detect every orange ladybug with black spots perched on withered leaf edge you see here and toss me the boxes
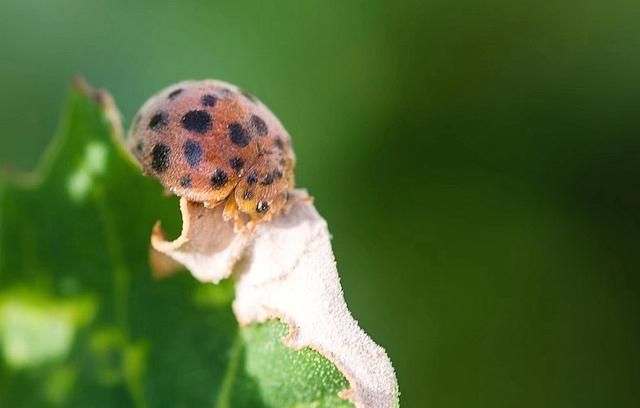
[127,80,295,224]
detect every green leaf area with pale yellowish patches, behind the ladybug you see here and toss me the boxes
[0,79,352,407]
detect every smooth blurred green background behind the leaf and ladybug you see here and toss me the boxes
[0,0,640,407]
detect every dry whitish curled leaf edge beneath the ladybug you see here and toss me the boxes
[151,196,398,408]
